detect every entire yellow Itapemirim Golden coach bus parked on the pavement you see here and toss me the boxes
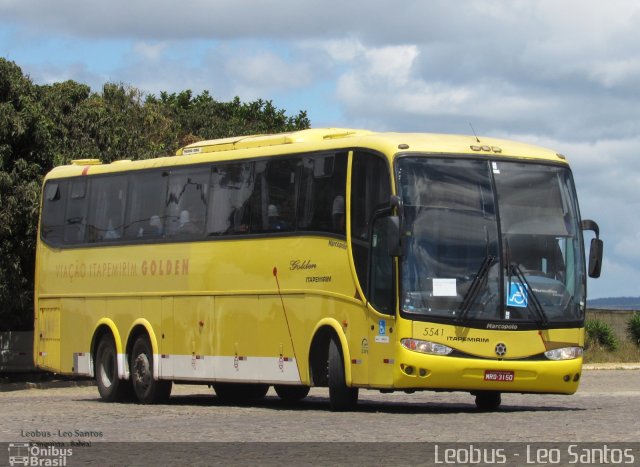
[34,128,602,410]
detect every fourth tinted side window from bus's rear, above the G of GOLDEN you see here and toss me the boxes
[124,170,168,239]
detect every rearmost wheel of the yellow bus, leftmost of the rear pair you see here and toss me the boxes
[95,336,133,402]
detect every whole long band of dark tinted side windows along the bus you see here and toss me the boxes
[42,152,347,249]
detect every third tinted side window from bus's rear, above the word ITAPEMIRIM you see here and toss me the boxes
[87,175,127,243]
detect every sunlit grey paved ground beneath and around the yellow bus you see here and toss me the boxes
[0,370,640,466]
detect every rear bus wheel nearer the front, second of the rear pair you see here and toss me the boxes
[131,336,171,404]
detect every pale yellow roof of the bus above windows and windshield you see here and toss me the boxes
[47,128,566,178]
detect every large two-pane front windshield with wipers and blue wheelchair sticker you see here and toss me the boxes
[397,156,585,326]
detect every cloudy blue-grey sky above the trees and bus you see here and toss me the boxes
[0,0,640,298]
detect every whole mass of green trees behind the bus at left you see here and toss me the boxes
[0,58,310,331]
